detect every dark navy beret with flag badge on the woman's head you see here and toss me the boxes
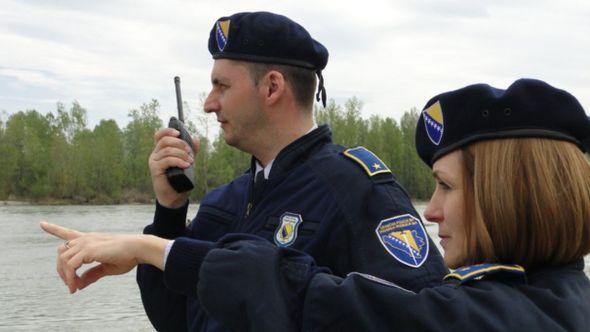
[416,79,590,167]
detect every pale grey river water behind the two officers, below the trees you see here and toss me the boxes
[0,205,590,331]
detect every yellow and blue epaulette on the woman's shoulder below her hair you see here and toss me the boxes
[444,264,525,284]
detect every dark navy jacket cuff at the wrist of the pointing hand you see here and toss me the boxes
[164,237,218,298]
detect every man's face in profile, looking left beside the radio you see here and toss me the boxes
[205,59,264,152]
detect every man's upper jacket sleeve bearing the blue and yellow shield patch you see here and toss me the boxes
[328,174,448,292]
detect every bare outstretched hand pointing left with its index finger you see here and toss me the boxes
[40,222,168,293]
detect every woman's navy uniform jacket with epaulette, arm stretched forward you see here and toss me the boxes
[198,236,590,331]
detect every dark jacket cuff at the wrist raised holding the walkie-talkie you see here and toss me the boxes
[143,200,188,239]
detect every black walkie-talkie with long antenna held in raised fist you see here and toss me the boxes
[166,76,195,193]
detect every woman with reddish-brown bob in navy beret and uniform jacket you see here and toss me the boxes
[198,79,590,331]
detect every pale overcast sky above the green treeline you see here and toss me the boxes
[0,0,590,132]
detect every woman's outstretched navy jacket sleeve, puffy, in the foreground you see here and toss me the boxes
[198,239,542,331]
